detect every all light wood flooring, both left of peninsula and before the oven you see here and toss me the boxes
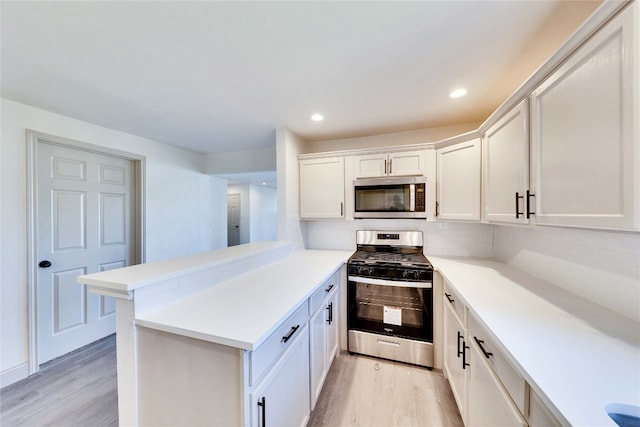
[0,336,462,427]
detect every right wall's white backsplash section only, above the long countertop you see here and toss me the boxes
[493,225,640,321]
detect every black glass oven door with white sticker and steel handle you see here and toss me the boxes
[347,276,433,342]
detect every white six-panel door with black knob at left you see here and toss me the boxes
[36,141,135,364]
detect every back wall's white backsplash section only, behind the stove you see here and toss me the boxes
[306,219,493,258]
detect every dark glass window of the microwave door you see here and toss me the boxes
[355,185,411,212]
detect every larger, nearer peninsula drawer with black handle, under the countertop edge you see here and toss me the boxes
[249,300,308,385]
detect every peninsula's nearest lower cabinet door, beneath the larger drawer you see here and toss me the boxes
[249,326,311,427]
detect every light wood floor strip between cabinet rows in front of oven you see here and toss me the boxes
[308,352,463,427]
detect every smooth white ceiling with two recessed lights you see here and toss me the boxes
[0,1,597,153]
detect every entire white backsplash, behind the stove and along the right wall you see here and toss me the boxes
[304,219,640,322]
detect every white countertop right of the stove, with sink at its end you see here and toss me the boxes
[429,256,640,426]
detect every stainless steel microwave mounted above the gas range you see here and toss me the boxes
[353,176,427,218]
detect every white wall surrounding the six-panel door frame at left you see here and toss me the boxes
[0,99,226,385]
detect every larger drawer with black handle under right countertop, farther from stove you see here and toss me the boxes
[468,315,526,414]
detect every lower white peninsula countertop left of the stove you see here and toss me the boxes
[136,250,352,350]
